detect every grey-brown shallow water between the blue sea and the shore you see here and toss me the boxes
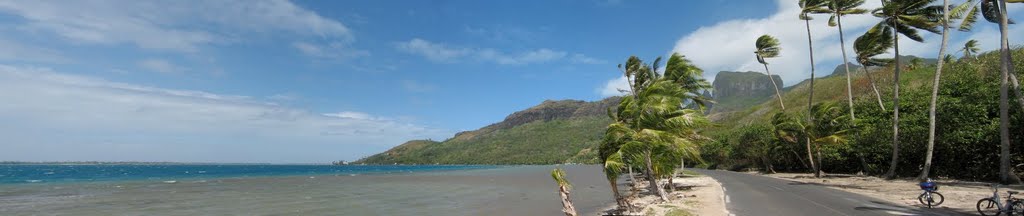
[0,166,614,215]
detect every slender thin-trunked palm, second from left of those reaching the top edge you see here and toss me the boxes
[828,0,867,120]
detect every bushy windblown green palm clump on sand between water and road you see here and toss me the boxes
[602,54,710,201]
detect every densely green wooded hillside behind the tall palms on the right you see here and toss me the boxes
[701,48,1024,180]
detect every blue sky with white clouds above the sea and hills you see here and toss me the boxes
[0,0,1024,163]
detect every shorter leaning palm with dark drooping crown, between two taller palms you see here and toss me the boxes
[853,26,893,112]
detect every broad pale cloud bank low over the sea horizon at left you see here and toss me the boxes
[0,66,451,163]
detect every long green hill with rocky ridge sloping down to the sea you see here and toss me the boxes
[354,97,622,165]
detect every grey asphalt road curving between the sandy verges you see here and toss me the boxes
[694,169,961,216]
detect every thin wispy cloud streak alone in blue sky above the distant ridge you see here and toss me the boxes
[395,38,603,64]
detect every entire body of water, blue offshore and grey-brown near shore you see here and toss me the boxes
[0,165,625,215]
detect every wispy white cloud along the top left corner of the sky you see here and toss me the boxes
[0,0,354,52]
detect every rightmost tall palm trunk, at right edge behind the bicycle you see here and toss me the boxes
[999,0,1020,184]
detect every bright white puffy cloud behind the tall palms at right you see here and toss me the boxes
[659,0,1024,89]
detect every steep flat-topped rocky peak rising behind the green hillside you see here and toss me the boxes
[709,72,783,113]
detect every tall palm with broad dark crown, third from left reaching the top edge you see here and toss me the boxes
[871,0,942,179]
